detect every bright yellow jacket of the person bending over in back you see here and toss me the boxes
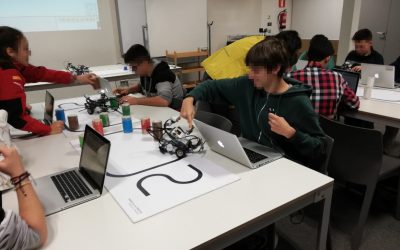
[201,36,265,80]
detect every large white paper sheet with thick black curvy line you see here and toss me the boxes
[105,131,240,222]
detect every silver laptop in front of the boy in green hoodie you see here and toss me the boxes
[194,119,282,168]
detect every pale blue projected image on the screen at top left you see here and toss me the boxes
[0,0,100,32]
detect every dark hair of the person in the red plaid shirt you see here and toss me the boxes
[307,34,335,62]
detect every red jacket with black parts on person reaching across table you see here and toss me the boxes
[0,64,74,135]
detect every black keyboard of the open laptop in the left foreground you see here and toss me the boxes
[51,170,92,202]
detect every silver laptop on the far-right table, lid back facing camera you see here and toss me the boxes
[361,63,395,89]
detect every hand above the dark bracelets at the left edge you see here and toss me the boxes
[0,146,25,178]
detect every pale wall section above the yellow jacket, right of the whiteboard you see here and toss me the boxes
[207,0,261,52]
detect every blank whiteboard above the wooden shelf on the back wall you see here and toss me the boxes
[146,0,207,57]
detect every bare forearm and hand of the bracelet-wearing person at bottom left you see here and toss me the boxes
[0,147,47,245]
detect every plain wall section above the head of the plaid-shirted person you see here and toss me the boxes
[292,0,347,40]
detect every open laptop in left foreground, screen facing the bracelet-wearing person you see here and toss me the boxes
[34,125,111,215]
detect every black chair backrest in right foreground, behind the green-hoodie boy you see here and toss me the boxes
[320,116,383,185]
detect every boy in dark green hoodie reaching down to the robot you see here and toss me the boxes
[181,38,324,168]
